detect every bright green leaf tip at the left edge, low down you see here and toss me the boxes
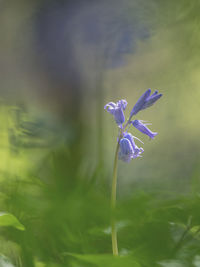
[0,212,25,231]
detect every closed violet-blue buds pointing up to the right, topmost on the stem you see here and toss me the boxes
[129,89,162,117]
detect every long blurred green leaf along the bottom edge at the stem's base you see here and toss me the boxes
[65,253,141,267]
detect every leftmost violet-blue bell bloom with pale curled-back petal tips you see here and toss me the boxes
[104,99,127,126]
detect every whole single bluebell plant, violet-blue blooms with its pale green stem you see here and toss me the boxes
[104,89,162,256]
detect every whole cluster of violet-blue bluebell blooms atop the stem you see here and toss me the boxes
[104,89,162,162]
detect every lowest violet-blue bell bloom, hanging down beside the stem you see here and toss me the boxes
[119,133,144,162]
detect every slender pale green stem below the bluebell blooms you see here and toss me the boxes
[111,142,119,255]
